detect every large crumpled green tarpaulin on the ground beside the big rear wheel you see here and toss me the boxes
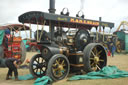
[68,66,128,81]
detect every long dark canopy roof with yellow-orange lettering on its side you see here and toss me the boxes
[19,11,114,29]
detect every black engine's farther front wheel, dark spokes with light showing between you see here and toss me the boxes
[29,54,47,77]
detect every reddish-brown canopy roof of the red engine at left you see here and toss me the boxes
[0,24,30,31]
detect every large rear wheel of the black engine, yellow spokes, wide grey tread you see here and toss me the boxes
[83,43,107,72]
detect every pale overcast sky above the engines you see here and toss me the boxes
[0,0,128,30]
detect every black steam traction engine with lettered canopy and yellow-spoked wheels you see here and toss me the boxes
[19,0,114,81]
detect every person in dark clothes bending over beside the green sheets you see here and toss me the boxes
[5,58,22,80]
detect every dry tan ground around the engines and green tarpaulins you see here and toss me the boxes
[0,53,128,85]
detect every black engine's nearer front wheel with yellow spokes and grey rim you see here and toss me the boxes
[47,54,70,81]
